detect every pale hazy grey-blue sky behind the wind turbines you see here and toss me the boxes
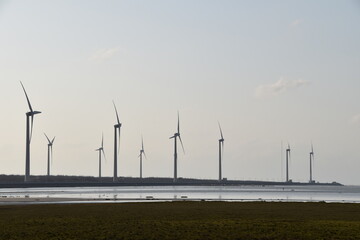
[0,0,360,184]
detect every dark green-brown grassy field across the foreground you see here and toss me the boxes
[0,202,360,240]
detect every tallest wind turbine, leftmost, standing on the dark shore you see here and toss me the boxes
[20,81,41,182]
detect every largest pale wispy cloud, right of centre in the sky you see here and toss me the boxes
[255,78,309,98]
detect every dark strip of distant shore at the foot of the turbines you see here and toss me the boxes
[0,175,342,188]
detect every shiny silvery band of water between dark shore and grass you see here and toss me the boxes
[0,186,360,203]
